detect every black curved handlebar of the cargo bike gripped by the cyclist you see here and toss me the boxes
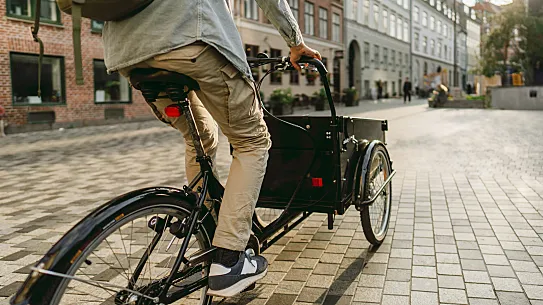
[247,56,337,121]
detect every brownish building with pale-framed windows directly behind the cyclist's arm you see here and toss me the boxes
[233,0,345,99]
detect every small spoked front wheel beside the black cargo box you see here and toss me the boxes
[360,143,392,246]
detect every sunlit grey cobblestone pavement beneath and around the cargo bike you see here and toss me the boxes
[0,100,543,305]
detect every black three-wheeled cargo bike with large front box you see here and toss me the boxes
[11,55,395,305]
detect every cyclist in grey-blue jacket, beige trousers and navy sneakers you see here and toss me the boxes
[103,0,322,297]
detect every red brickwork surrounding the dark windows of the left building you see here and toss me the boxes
[0,0,152,131]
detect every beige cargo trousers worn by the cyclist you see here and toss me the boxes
[119,42,271,251]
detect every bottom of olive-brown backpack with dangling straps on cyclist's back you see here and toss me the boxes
[32,0,153,95]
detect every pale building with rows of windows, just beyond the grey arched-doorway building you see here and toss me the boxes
[411,0,454,88]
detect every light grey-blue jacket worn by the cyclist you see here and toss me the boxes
[102,0,303,79]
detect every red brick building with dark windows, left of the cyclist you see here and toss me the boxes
[0,0,152,133]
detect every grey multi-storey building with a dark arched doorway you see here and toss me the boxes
[345,0,411,97]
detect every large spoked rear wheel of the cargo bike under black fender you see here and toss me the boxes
[50,198,214,305]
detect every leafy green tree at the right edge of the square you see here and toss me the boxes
[478,2,543,83]
